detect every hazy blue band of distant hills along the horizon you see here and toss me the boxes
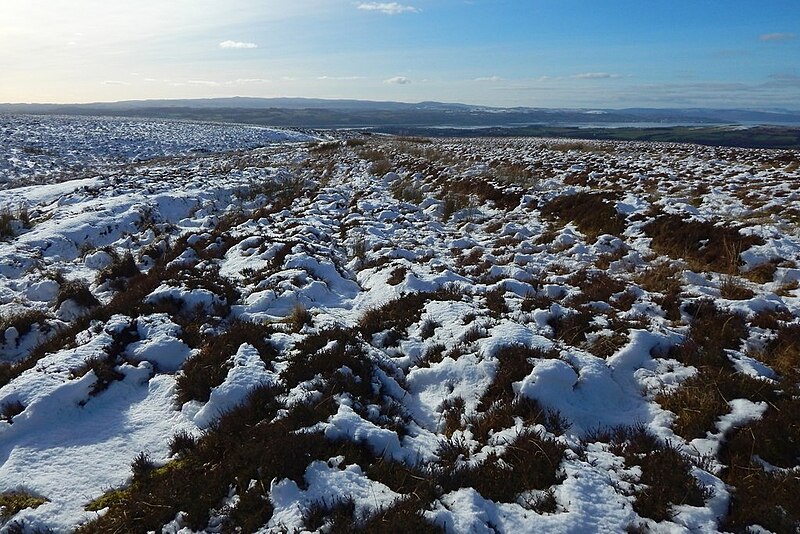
[0,97,800,128]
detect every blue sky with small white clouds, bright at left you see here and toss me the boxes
[0,0,800,110]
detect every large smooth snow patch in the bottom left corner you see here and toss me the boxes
[0,363,193,530]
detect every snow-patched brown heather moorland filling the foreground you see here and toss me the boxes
[0,119,800,532]
